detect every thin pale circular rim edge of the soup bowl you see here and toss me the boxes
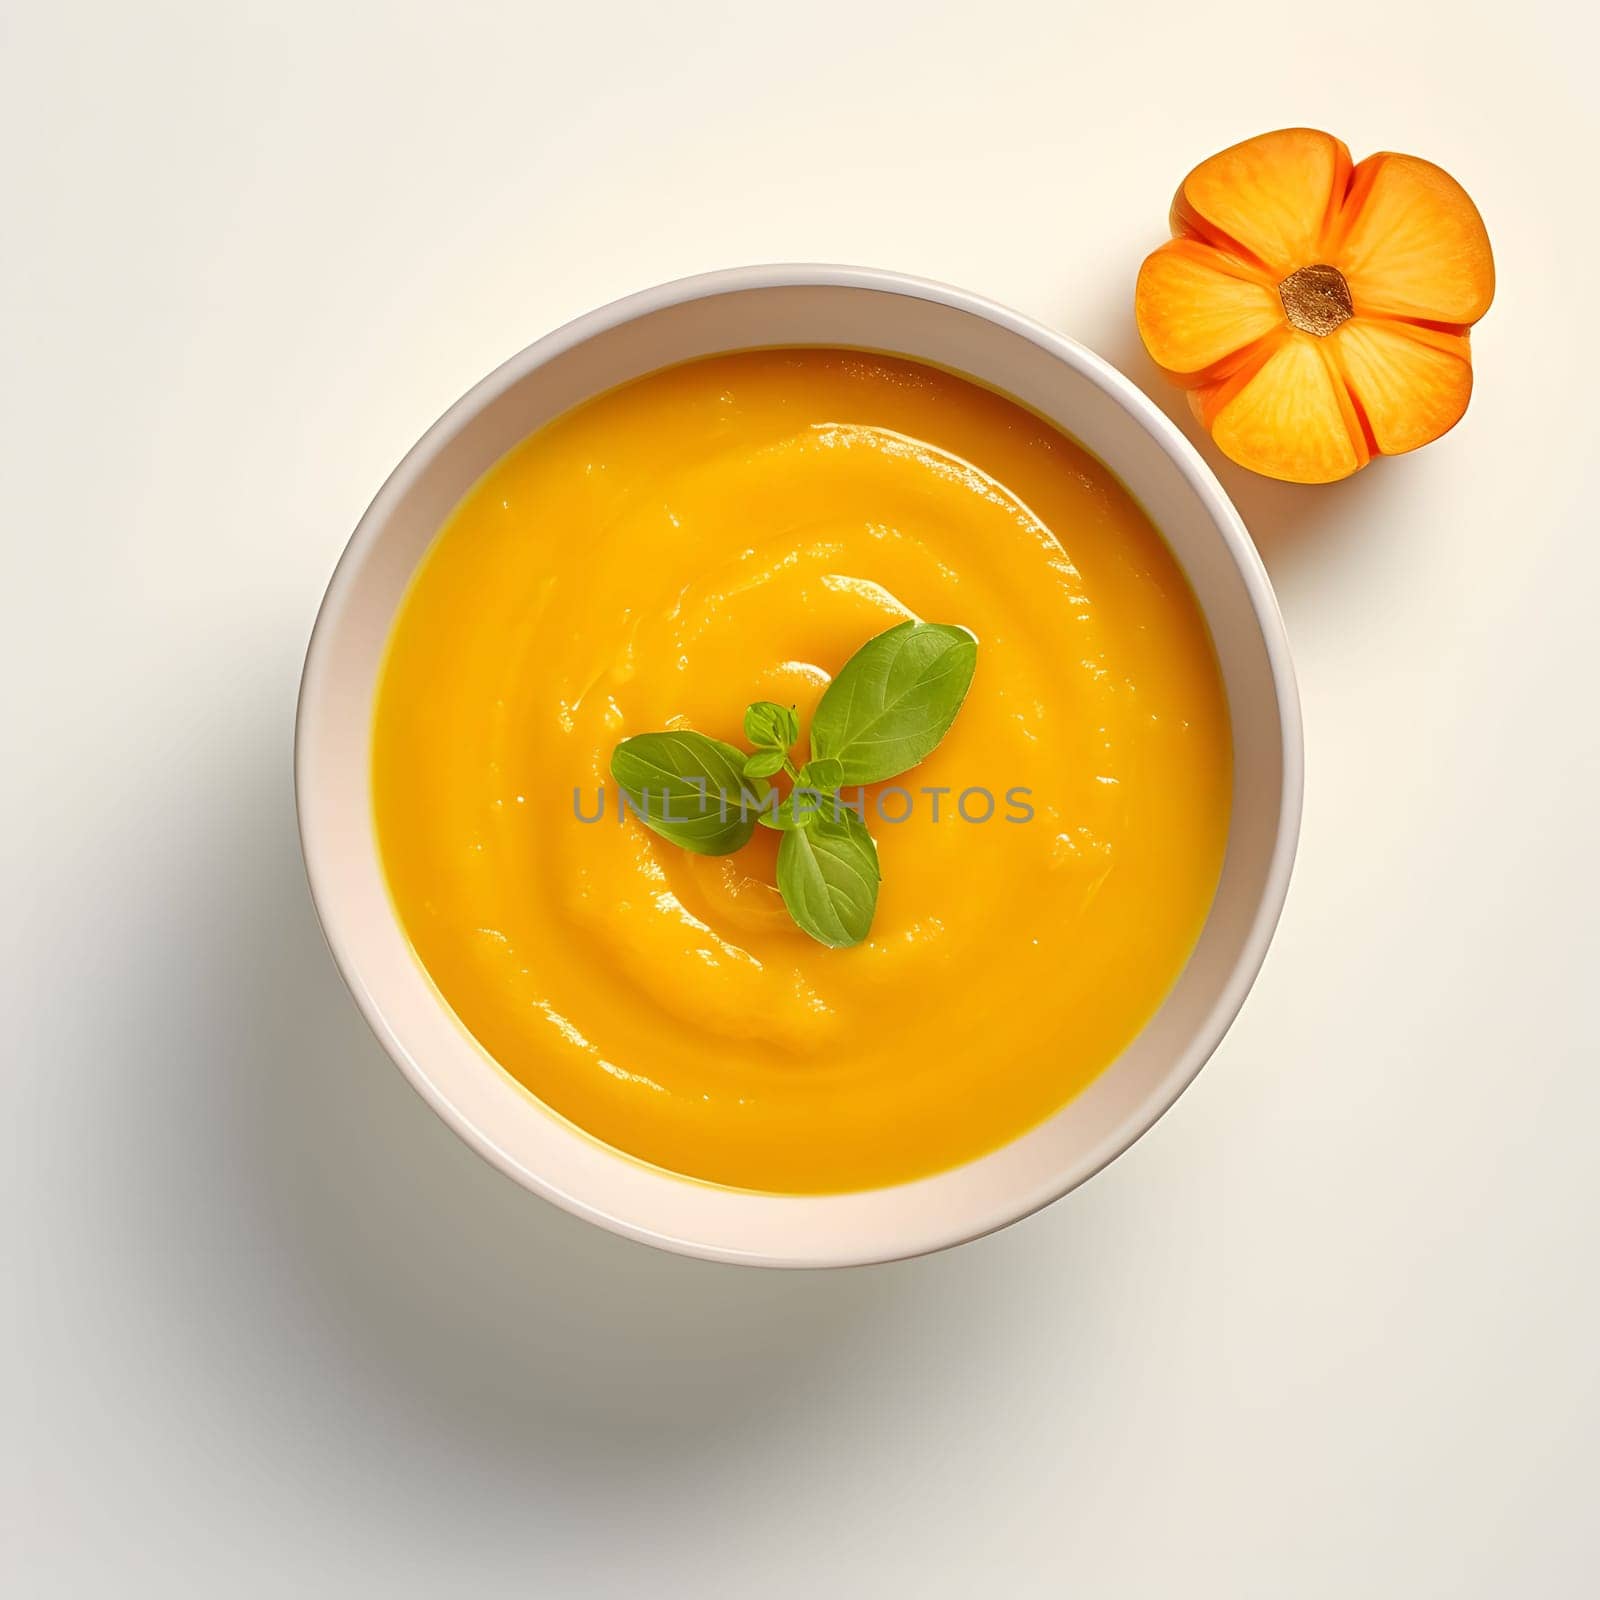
[294,262,1306,1267]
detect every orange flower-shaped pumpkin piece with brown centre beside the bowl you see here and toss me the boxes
[1134,128,1494,483]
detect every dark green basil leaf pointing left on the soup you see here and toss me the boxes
[611,731,771,856]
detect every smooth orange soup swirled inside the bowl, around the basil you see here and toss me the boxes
[373,349,1232,1192]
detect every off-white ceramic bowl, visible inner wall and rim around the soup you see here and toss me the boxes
[294,266,1302,1267]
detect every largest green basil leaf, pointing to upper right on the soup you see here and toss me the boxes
[811,622,978,784]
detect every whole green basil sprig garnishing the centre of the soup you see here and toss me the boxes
[611,622,978,947]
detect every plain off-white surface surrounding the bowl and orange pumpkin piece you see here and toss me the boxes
[0,0,1600,1600]
